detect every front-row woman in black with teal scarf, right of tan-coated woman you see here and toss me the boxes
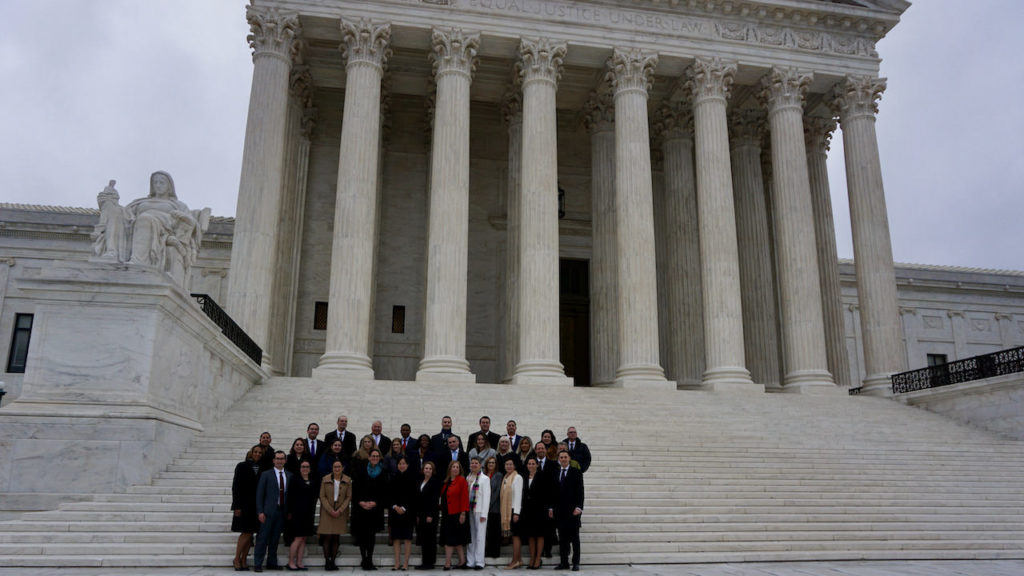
[352,448,387,570]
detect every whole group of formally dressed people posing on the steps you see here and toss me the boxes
[231,415,591,572]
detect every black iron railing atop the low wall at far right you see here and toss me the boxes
[892,346,1024,394]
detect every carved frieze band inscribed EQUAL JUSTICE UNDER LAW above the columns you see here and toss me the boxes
[408,0,878,57]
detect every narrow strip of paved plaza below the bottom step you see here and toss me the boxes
[0,560,1024,576]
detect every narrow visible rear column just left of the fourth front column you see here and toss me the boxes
[502,91,522,382]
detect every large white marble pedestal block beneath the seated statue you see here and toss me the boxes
[0,262,264,493]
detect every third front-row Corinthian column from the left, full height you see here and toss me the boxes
[416,29,480,382]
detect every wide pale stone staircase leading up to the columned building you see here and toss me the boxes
[0,378,1024,567]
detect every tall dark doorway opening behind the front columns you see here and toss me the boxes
[558,258,590,386]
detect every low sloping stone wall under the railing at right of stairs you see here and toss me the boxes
[897,373,1024,440]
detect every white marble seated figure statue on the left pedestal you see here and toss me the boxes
[92,171,210,289]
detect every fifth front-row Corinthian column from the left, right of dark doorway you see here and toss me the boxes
[608,48,676,389]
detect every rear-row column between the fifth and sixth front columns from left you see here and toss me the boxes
[654,99,705,386]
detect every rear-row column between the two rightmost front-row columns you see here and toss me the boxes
[804,117,850,387]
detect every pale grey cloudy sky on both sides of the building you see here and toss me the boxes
[0,0,1024,270]
